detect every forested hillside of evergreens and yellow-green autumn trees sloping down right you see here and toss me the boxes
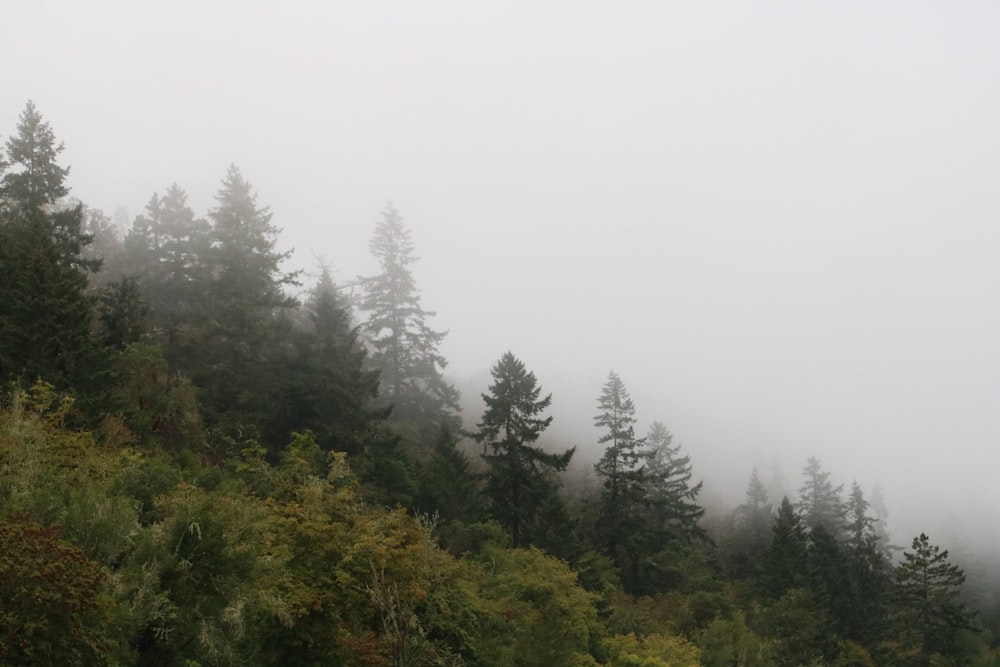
[0,103,1000,667]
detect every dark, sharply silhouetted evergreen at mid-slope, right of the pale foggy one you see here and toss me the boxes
[475,352,574,547]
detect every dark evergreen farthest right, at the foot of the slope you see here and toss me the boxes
[893,533,973,667]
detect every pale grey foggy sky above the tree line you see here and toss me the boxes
[0,0,1000,548]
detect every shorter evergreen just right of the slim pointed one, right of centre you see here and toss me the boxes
[644,422,708,541]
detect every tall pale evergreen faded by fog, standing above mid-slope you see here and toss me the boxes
[361,204,461,441]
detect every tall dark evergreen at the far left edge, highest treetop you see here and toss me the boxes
[0,102,107,397]
